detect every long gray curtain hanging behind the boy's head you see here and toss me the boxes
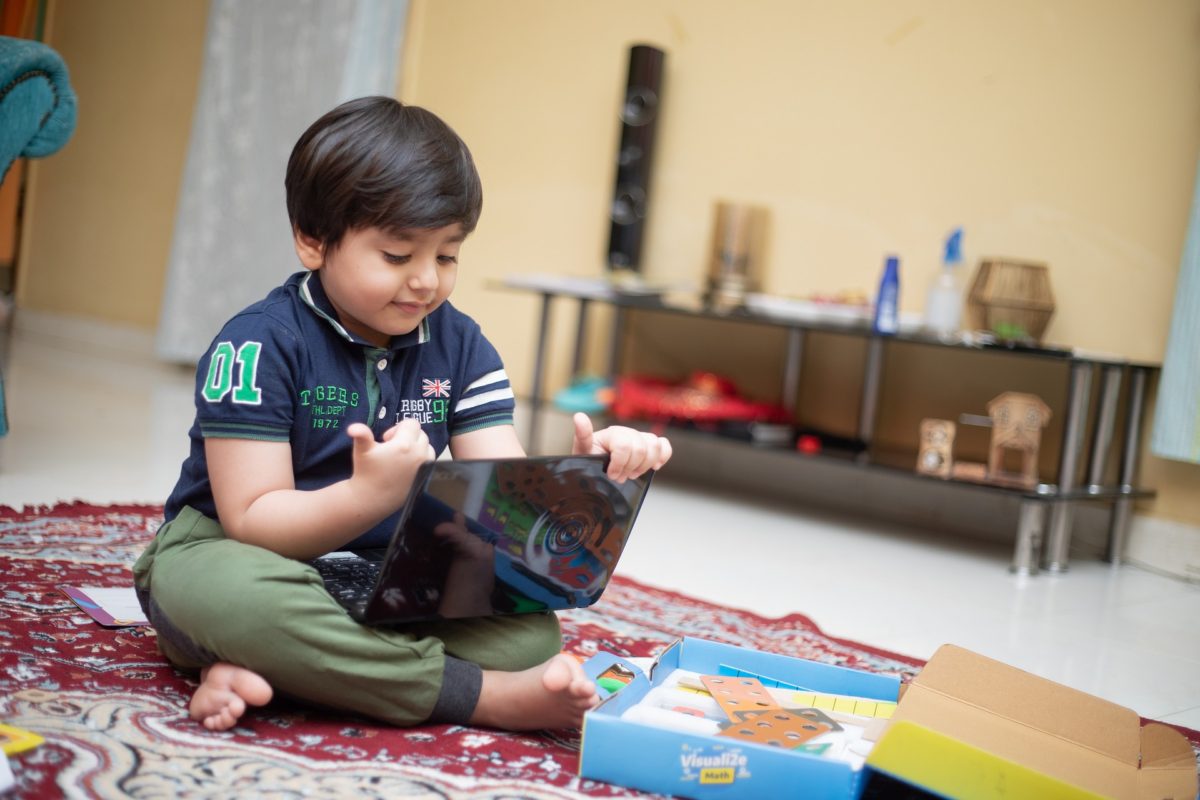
[157,0,408,362]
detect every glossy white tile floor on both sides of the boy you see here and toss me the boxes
[0,319,1200,728]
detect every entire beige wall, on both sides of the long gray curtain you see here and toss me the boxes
[20,0,1200,524]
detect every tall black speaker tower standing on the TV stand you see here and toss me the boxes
[608,44,666,272]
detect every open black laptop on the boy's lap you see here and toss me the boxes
[304,456,654,625]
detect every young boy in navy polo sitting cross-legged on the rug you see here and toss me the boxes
[134,97,671,730]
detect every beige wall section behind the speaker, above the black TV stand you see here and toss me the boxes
[403,0,1200,360]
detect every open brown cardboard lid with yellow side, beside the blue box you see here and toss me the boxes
[868,644,1198,800]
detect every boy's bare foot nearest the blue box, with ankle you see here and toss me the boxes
[470,652,600,730]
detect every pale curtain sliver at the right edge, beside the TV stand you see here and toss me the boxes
[1150,158,1200,463]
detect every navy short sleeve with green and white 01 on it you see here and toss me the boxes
[196,313,300,441]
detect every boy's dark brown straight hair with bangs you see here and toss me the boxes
[283,97,484,248]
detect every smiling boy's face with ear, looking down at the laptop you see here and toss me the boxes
[295,224,466,347]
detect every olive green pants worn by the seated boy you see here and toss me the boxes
[133,507,562,726]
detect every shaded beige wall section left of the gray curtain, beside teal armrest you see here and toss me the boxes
[17,0,208,329]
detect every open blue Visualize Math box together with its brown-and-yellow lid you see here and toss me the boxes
[580,638,1198,800]
